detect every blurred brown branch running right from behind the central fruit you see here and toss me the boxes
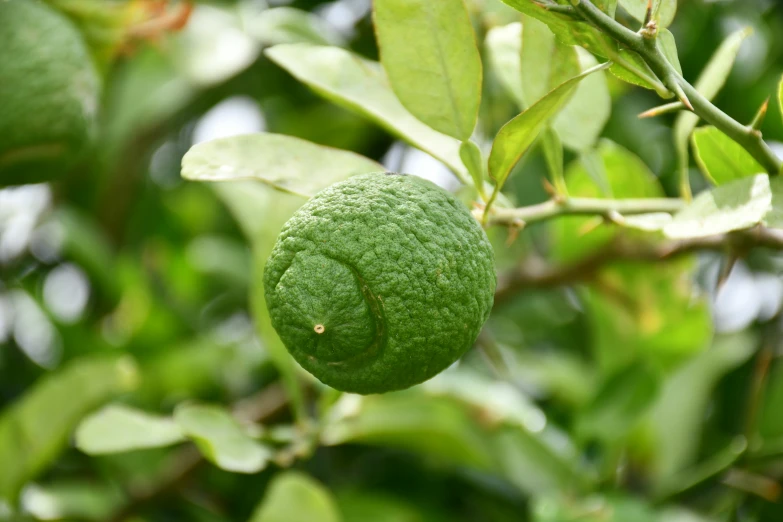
[495,227,783,305]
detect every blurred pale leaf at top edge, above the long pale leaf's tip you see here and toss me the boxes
[244,7,345,46]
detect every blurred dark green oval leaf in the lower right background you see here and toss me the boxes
[576,363,660,443]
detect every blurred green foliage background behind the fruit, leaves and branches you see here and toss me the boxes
[0,0,783,522]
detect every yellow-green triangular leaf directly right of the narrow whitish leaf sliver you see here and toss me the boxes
[520,16,581,107]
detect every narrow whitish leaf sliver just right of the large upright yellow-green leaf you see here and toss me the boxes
[484,22,525,109]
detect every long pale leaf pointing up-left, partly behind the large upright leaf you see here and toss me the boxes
[266,44,469,183]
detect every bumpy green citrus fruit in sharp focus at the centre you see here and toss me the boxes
[264,173,496,394]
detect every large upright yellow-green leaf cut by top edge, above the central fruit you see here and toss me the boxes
[373,0,482,141]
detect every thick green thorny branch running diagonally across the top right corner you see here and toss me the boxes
[571,0,783,176]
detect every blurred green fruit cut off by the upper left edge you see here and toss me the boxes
[0,0,100,186]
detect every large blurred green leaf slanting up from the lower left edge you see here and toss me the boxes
[0,357,138,503]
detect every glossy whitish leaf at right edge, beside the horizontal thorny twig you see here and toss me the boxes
[663,174,772,239]
